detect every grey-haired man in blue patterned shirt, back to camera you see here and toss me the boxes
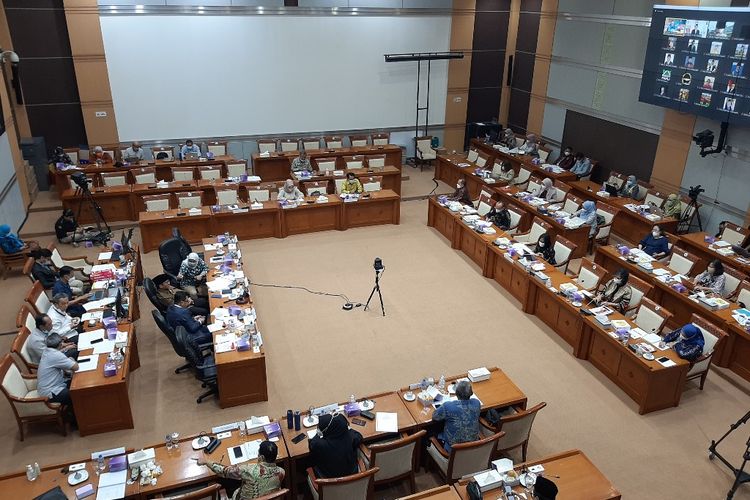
[432,380,481,453]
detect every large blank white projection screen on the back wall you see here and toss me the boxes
[101,15,451,142]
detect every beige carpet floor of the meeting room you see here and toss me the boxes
[0,171,750,499]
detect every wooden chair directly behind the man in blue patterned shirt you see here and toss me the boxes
[427,432,504,484]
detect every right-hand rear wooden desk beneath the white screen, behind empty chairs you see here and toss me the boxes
[252,144,401,181]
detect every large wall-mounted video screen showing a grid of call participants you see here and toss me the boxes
[639,5,750,123]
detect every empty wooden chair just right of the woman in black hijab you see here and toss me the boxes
[359,429,427,493]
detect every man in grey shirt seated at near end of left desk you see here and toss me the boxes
[36,333,78,406]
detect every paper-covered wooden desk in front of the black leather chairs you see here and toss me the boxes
[203,238,268,408]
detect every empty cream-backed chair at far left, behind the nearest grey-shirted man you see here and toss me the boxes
[0,354,67,441]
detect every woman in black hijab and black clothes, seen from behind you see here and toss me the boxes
[307,413,362,478]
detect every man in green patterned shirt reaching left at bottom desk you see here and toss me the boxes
[196,441,285,500]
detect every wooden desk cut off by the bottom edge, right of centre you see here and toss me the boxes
[452,450,621,500]
